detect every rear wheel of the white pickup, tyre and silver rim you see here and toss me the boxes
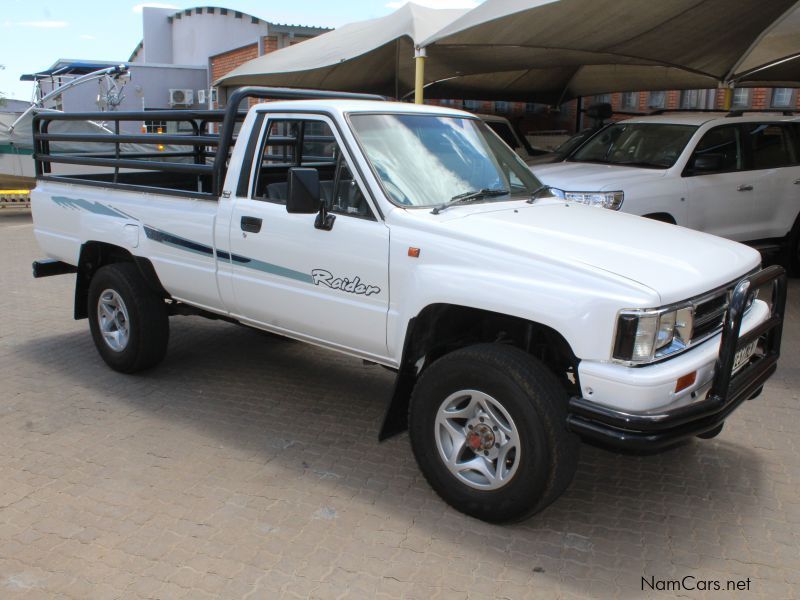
[89,263,169,373]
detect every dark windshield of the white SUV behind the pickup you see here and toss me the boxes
[569,122,697,169]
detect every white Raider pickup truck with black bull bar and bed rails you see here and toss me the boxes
[32,88,786,522]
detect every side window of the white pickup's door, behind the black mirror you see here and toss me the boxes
[253,119,374,218]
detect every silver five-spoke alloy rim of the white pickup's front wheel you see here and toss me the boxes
[435,390,520,490]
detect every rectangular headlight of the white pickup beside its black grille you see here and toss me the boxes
[613,306,694,364]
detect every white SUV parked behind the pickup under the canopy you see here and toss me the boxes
[533,113,800,270]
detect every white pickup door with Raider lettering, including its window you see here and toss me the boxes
[229,115,389,357]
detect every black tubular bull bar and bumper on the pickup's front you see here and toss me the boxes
[567,267,786,451]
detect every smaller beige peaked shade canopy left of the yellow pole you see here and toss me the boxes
[214,3,467,97]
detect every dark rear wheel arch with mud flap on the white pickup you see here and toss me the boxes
[74,241,169,320]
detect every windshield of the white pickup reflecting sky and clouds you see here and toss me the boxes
[350,114,541,207]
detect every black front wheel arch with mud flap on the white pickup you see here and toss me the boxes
[379,303,579,440]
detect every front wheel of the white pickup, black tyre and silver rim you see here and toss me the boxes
[409,344,579,523]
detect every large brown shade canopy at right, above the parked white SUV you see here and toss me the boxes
[422,0,800,101]
